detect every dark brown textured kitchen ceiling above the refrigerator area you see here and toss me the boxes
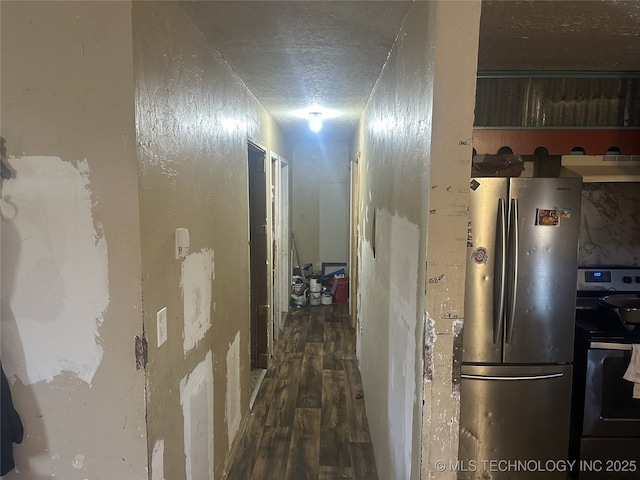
[478,0,640,72]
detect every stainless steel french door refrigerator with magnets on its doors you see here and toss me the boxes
[458,174,582,480]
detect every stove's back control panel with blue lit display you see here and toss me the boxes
[578,267,640,292]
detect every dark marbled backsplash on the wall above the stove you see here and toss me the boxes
[578,183,640,266]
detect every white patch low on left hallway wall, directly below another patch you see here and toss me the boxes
[180,351,213,480]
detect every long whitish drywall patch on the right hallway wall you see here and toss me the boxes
[357,209,422,480]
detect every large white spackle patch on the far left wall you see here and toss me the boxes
[2,157,109,384]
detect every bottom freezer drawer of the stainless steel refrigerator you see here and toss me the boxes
[458,365,572,480]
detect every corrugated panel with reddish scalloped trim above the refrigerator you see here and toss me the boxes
[473,72,640,161]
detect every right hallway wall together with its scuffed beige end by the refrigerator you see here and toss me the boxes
[353,2,480,480]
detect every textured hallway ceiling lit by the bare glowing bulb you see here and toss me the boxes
[183,0,410,139]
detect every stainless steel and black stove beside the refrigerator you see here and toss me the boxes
[571,267,640,480]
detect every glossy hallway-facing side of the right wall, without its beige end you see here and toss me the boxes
[356,2,431,480]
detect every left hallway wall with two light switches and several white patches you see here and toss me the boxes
[133,1,288,479]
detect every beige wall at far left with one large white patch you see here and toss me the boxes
[0,1,148,480]
